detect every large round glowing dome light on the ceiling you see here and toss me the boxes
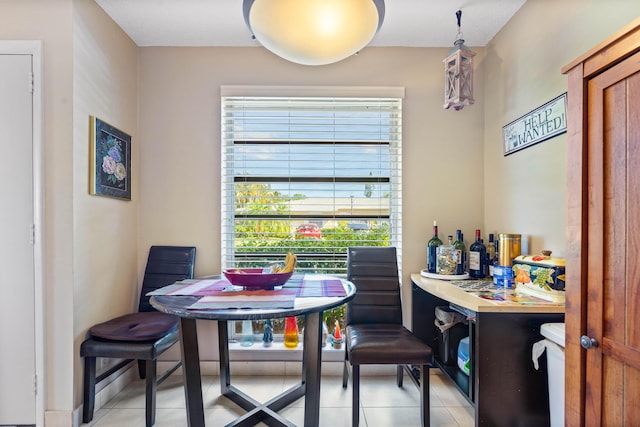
[242,0,385,65]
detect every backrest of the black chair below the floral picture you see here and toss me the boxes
[138,246,196,311]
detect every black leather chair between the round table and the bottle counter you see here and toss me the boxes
[342,247,433,427]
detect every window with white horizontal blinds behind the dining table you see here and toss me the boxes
[222,88,402,348]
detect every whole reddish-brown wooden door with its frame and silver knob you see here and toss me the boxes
[563,20,640,426]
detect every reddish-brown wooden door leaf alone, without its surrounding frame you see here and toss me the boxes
[585,53,640,426]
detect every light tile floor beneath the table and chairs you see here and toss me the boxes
[84,369,474,427]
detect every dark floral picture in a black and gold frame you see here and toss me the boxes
[89,116,131,200]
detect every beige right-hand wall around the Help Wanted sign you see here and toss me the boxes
[484,0,640,257]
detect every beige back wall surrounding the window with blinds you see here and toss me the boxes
[139,48,484,357]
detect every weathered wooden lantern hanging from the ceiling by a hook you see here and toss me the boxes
[442,10,476,111]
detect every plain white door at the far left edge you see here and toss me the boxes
[0,55,36,425]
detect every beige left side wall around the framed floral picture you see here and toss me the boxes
[73,0,138,407]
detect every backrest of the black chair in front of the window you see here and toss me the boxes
[346,247,402,325]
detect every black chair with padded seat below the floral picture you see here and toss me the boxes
[80,246,196,427]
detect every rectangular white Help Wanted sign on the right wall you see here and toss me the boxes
[502,92,567,156]
